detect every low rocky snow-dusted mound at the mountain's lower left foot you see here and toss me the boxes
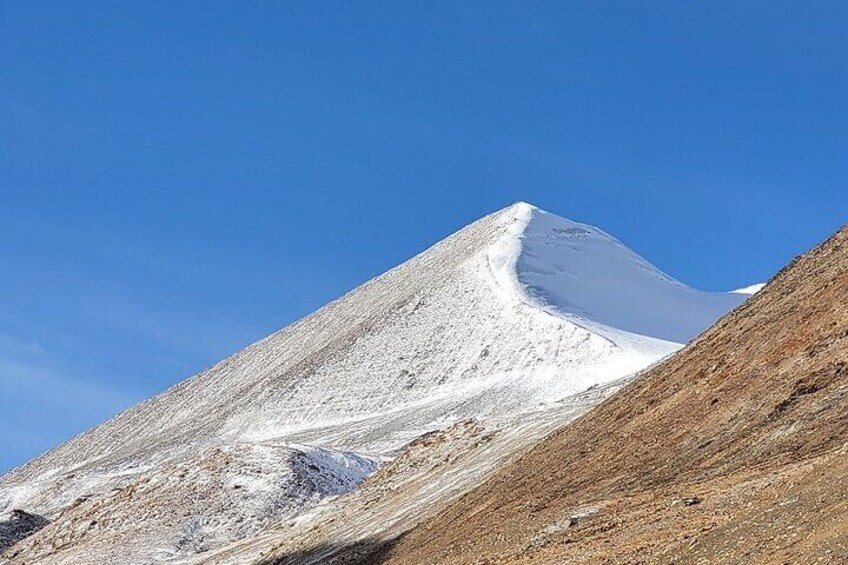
[0,444,377,563]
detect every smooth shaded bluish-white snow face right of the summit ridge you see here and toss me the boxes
[489,202,742,343]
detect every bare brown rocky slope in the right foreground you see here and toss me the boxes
[366,227,848,564]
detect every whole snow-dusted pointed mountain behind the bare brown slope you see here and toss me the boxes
[0,203,746,563]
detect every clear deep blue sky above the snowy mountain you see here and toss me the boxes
[0,0,848,470]
